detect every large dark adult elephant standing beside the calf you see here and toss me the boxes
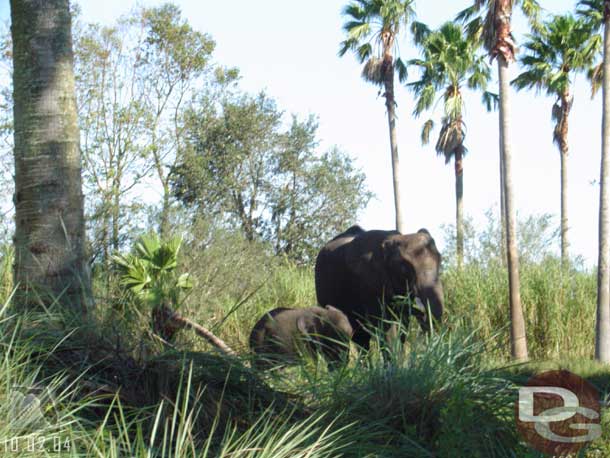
[315,226,443,348]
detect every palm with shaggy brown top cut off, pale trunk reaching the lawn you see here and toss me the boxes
[457,0,540,360]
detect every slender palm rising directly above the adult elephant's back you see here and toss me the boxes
[339,0,414,233]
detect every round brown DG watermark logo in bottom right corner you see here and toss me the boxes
[515,371,602,456]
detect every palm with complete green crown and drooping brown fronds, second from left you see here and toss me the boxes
[408,22,491,268]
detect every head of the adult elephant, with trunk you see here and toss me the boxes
[381,229,443,330]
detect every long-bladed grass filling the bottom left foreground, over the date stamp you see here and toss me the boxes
[0,296,350,458]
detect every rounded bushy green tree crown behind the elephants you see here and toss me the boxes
[172,94,371,262]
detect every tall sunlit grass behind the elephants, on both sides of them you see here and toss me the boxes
[184,254,596,360]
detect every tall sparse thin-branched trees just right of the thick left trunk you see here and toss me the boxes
[74,3,238,267]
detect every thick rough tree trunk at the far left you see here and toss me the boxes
[10,0,92,313]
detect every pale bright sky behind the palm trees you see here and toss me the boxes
[0,0,601,264]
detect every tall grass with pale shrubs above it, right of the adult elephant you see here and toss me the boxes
[443,211,597,359]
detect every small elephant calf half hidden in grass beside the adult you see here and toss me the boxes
[250,305,353,367]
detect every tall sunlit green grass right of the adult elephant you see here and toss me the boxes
[443,258,596,359]
